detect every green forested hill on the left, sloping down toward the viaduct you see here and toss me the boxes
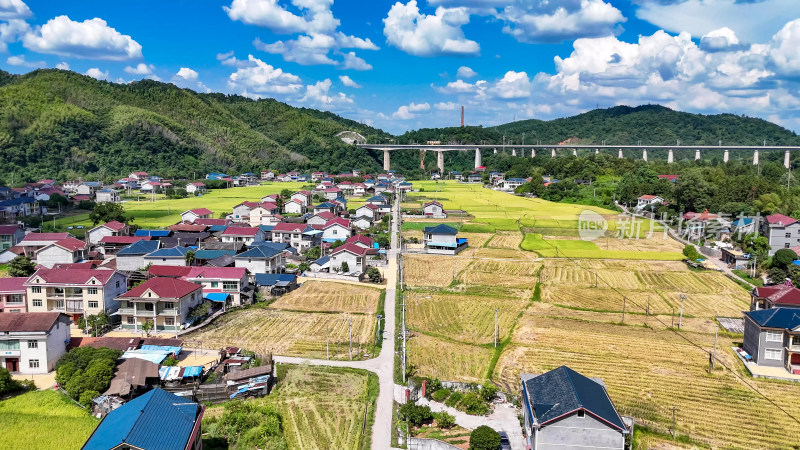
[0,70,389,183]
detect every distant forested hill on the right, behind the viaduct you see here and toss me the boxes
[399,105,800,145]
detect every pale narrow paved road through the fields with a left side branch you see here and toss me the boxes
[273,198,400,450]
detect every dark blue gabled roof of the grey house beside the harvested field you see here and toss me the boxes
[523,366,625,431]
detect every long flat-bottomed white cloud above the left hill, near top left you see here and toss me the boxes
[22,16,142,61]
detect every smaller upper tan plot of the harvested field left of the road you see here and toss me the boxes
[270,281,381,314]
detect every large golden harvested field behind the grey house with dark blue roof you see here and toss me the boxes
[495,319,800,448]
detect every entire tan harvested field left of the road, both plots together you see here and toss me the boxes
[184,282,381,359]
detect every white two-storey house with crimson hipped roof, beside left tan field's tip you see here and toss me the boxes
[117,277,203,331]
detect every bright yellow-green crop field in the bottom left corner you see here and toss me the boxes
[0,391,100,450]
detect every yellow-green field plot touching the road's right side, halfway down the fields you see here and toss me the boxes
[406,292,528,344]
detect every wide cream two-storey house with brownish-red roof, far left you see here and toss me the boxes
[25,268,128,321]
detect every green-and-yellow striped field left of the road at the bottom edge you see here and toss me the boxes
[200,365,378,450]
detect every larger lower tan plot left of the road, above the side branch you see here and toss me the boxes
[184,308,376,359]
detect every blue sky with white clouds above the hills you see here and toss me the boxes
[0,0,800,133]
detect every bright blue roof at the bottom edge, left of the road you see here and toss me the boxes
[83,388,201,450]
